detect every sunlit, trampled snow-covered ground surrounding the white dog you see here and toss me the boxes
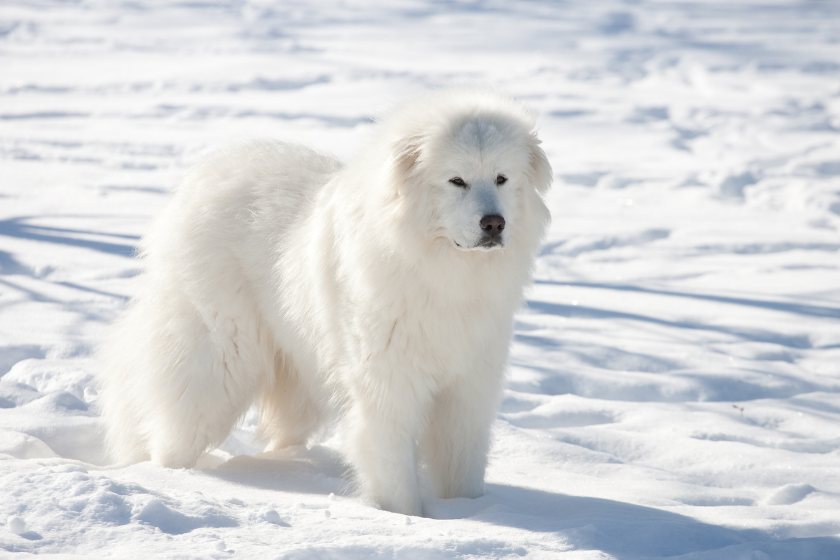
[0,0,840,560]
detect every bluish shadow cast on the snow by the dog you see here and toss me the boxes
[194,446,840,558]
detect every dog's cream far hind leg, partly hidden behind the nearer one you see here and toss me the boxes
[254,352,321,451]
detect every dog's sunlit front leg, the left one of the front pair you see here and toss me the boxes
[348,376,430,515]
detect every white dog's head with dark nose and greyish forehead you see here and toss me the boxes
[391,90,552,251]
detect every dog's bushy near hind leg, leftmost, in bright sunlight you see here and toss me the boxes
[102,280,274,467]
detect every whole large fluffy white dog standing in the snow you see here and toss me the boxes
[99,90,552,515]
